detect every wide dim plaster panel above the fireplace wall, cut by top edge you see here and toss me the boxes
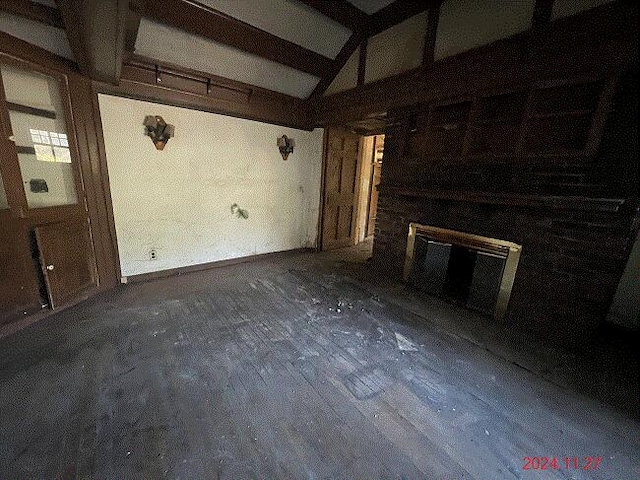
[434,0,535,60]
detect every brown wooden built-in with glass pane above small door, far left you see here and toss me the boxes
[0,57,96,320]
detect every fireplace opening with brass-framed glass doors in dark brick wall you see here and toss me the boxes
[404,223,522,320]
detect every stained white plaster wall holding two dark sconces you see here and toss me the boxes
[99,95,322,276]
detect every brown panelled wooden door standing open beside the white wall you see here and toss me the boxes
[322,127,360,250]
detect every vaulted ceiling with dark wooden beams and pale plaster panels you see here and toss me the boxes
[0,0,607,99]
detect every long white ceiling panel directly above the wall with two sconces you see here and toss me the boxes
[135,18,319,98]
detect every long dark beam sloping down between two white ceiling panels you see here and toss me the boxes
[132,0,332,77]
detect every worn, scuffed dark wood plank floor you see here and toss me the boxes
[0,249,640,479]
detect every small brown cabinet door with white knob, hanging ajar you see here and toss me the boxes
[35,222,96,310]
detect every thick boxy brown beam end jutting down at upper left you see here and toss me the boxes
[57,0,129,84]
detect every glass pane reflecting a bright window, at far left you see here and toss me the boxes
[0,65,78,208]
